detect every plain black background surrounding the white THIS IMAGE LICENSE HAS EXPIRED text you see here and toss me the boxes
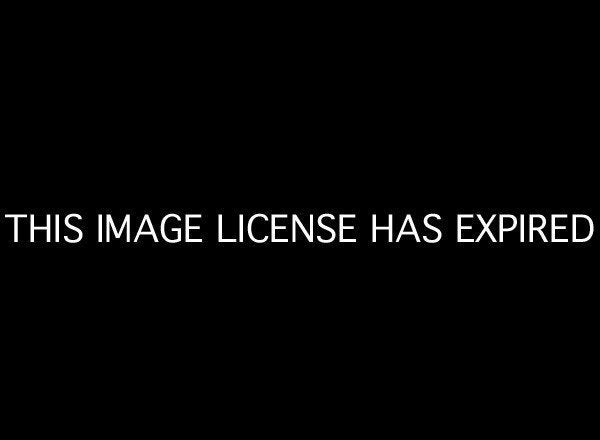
[1,5,598,433]
